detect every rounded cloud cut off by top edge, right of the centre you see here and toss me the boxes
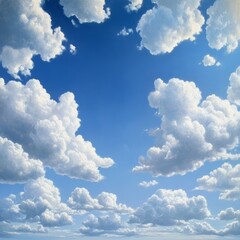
[136,0,204,55]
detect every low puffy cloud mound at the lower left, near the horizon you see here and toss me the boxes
[0,177,73,228]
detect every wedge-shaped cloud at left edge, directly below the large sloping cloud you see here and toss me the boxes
[0,137,45,183]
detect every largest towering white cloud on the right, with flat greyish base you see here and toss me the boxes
[133,75,240,176]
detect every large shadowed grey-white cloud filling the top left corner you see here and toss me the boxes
[0,0,65,78]
